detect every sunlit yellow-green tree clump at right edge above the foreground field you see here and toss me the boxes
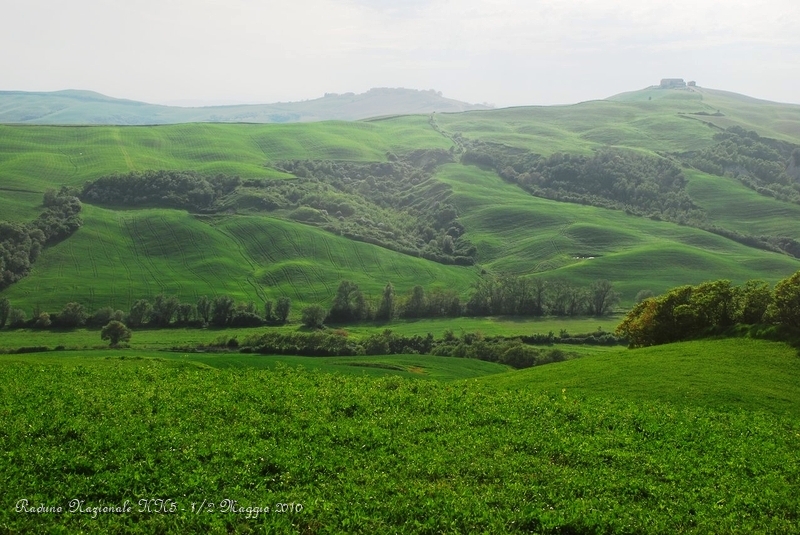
[617,271,800,347]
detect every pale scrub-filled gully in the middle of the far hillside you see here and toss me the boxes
[276,154,476,265]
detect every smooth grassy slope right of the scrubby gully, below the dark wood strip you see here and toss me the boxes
[437,165,800,304]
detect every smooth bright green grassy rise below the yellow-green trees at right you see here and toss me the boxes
[485,338,800,420]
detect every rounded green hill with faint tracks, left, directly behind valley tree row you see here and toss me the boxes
[3,205,477,311]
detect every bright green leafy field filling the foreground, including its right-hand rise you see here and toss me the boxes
[0,340,800,533]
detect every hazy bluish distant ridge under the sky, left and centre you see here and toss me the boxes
[0,88,488,125]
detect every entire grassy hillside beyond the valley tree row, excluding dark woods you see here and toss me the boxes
[0,84,800,311]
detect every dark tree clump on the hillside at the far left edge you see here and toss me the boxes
[0,187,83,290]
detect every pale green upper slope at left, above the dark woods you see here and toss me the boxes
[0,117,451,197]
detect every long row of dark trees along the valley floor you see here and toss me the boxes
[0,276,619,329]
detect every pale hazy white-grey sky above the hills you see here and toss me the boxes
[0,0,800,106]
